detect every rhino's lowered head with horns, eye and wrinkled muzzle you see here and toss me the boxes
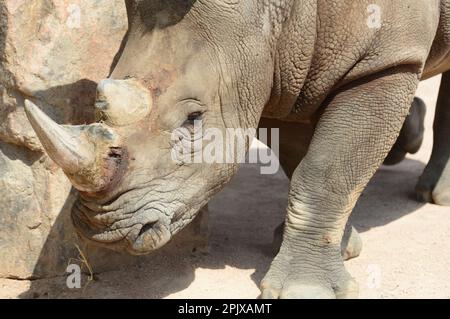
[25,0,280,254]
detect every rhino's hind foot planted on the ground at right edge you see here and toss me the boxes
[416,161,450,206]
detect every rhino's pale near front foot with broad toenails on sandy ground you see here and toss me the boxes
[261,246,358,299]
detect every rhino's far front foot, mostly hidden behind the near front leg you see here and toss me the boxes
[272,223,362,260]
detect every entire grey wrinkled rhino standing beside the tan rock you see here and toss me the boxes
[26,0,450,298]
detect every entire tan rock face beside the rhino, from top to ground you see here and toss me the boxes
[0,0,205,278]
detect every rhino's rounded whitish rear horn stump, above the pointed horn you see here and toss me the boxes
[95,79,152,126]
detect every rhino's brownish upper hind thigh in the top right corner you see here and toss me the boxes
[424,0,450,79]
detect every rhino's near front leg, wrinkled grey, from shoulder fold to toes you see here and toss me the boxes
[261,67,418,298]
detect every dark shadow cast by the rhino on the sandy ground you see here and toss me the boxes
[17,160,424,298]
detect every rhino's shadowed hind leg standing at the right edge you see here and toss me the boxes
[416,72,450,206]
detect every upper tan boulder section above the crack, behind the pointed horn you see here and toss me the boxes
[0,0,127,150]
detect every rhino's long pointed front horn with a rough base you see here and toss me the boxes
[25,100,124,193]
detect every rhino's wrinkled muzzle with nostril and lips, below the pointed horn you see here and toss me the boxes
[72,199,190,255]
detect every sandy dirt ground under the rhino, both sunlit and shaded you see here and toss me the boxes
[0,78,450,298]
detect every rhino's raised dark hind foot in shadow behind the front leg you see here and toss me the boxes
[384,97,426,165]
